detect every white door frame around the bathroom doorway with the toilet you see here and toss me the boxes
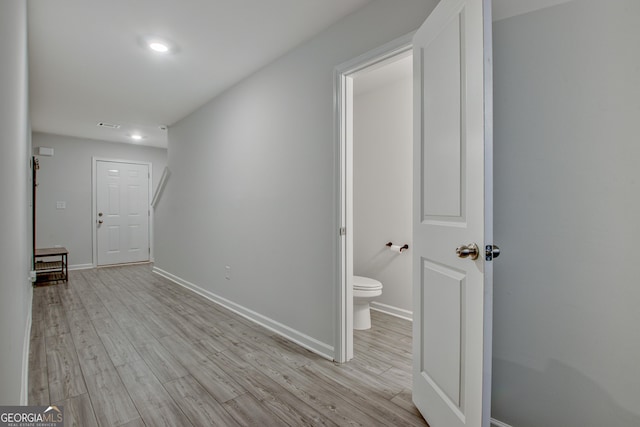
[334,32,414,363]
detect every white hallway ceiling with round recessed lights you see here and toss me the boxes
[28,0,370,147]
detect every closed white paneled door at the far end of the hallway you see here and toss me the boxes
[95,160,150,265]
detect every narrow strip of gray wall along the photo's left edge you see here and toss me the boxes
[0,1,31,405]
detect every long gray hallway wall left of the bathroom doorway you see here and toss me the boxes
[156,0,435,347]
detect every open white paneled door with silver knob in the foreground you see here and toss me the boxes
[413,0,493,427]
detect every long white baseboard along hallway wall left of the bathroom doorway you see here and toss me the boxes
[152,266,335,360]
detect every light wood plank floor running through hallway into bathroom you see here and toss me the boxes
[29,265,427,427]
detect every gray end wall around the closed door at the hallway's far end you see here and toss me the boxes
[33,132,167,267]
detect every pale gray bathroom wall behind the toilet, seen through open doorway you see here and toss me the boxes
[353,72,413,317]
